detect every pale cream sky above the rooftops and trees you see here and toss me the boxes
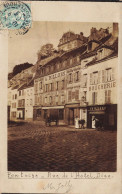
[8,21,112,72]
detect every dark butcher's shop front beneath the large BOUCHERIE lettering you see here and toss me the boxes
[87,105,117,130]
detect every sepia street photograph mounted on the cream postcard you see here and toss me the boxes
[7,21,119,172]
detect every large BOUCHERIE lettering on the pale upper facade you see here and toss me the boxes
[89,81,116,91]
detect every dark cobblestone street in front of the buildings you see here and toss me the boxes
[8,122,116,172]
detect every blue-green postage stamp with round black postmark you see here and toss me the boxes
[0,1,32,34]
